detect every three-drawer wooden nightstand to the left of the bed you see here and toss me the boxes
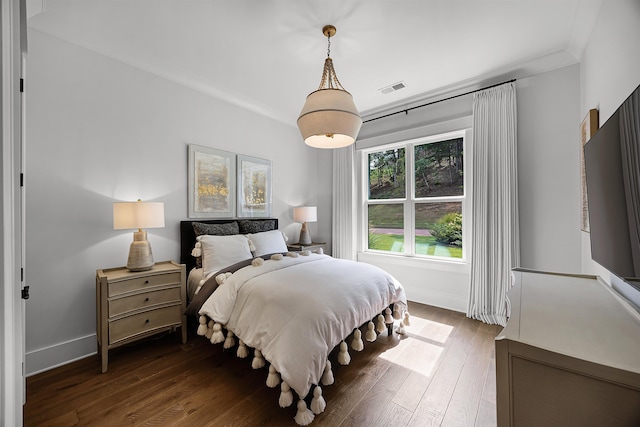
[96,261,187,373]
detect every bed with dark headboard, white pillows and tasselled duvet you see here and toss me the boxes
[180,219,409,425]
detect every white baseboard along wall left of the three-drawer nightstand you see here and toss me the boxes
[25,334,97,377]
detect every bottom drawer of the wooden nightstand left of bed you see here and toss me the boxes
[109,305,182,344]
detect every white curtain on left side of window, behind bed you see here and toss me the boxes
[331,144,357,260]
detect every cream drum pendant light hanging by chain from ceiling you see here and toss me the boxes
[298,25,362,148]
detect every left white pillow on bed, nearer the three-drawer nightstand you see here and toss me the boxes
[197,234,252,276]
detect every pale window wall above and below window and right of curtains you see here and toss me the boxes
[358,65,581,312]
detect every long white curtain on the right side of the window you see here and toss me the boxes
[467,83,520,326]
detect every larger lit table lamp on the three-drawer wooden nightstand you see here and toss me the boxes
[113,200,164,271]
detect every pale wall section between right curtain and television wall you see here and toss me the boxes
[517,65,581,273]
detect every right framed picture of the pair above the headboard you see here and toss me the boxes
[238,154,271,217]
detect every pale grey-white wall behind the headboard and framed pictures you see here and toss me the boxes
[26,31,331,374]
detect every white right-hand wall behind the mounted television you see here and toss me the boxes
[580,0,640,307]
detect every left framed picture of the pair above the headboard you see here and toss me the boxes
[188,144,236,218]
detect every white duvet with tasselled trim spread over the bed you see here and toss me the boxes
[192,253,408,425]
